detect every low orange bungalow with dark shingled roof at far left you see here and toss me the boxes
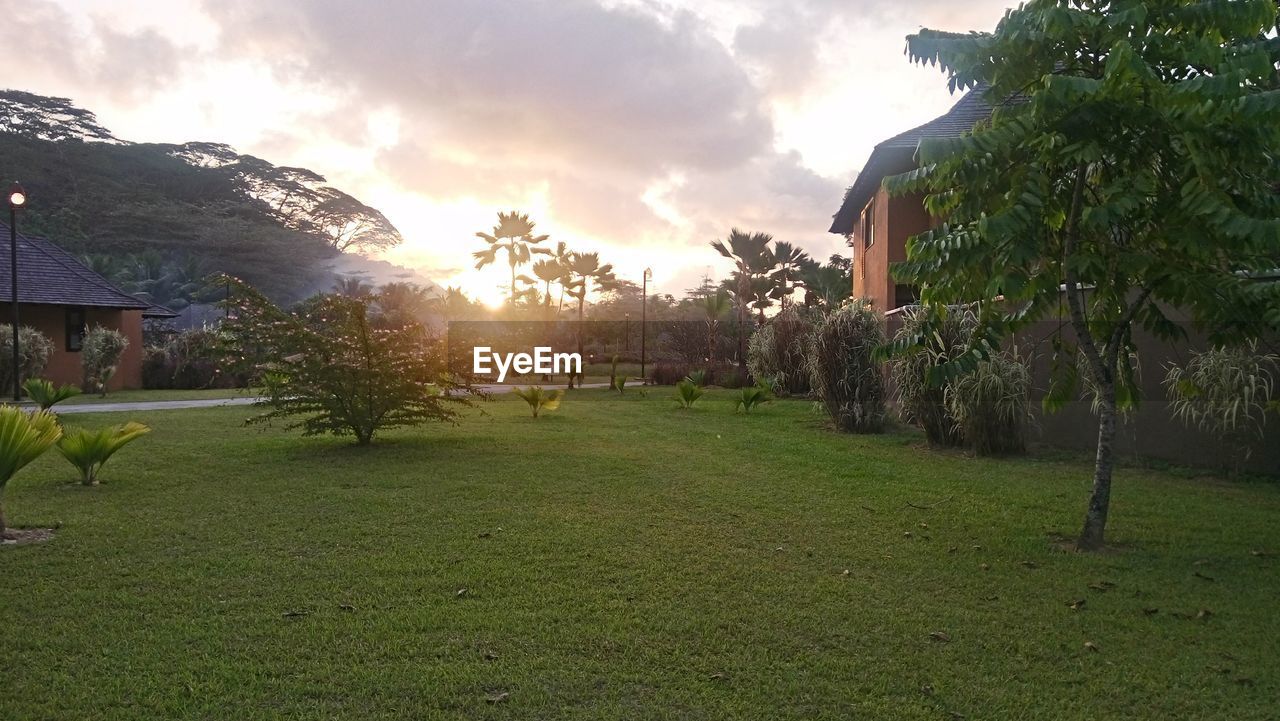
[0,223,174,391]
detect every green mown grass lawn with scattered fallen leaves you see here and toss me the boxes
[0,389,1280,721]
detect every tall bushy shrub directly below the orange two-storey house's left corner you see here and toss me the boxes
[809,304,887,433]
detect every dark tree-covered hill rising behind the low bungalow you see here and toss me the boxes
[0,90,401,307]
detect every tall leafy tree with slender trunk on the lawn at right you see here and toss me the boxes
[887,0,1280,549]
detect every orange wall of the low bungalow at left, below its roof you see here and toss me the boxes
[0,304,142,391]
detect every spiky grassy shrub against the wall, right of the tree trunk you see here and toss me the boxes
[1165,342,1280,461]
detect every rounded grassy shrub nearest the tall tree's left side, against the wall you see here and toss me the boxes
[945,353,1032,456]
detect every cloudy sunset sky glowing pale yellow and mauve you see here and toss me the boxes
[0,0,1006,301]
